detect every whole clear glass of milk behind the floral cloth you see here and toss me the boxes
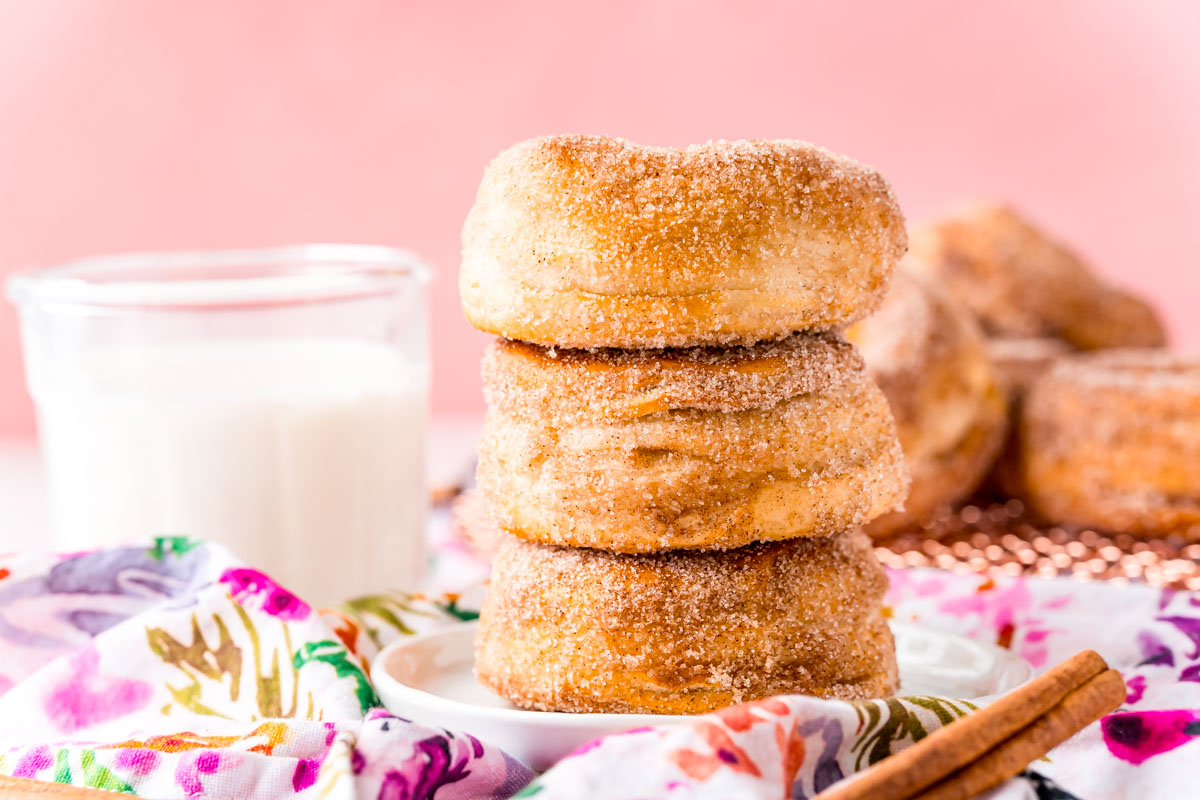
[10,245,431,604]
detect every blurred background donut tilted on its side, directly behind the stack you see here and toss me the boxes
[847,269,1007,536]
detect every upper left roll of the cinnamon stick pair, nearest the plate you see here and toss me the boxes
[814,650,1123,800]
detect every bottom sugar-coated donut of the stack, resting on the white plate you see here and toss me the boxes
[475,531,896,714]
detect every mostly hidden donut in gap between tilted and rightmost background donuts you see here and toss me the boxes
[985,338,1072,498]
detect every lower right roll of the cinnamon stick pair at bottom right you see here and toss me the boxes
[916,669,1126,800]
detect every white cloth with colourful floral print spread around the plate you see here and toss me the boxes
[0,539,1200,800]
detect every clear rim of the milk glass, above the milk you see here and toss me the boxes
[7,243,433,311]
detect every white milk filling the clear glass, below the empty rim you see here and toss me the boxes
[30,339,428,604]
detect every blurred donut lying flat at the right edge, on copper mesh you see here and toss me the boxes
[1022,350,1200,536]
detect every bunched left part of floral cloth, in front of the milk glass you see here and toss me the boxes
[0,539,533,800]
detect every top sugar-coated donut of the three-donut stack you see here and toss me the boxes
[458,136,907,349]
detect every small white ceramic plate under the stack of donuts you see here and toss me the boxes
[371,622,1033,770]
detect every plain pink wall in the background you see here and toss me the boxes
[0,0,1200,434]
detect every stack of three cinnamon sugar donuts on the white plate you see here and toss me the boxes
[460,137,907,714]
